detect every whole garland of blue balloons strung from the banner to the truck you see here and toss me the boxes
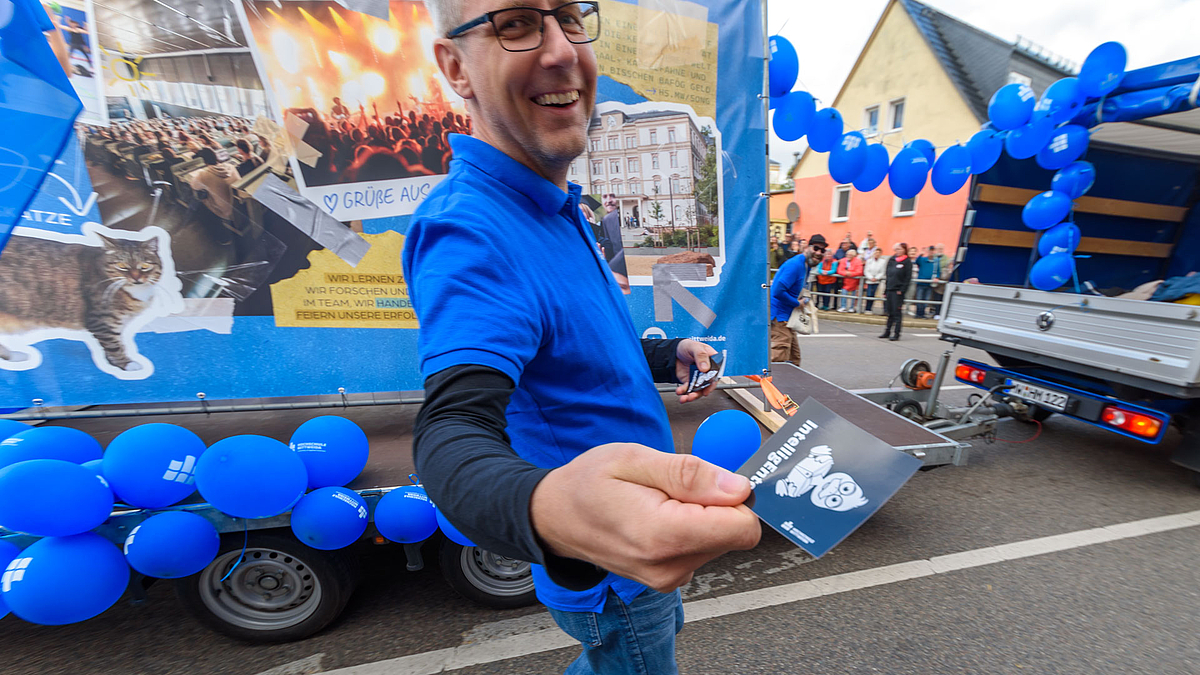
[768,35,1126,234]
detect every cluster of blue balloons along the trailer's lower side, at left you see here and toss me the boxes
[0,416,458,625]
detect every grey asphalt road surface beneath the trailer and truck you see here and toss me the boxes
[0,322,1200,675]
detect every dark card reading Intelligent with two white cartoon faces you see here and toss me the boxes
[738,399,920,557]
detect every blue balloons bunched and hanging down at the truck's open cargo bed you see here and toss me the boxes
[993,42,1127,291]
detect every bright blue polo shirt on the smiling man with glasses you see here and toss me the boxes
[402,135,674,611]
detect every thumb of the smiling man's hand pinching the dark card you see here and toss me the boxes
[618,450,750,506]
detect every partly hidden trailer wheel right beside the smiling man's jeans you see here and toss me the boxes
[438,539,538,609]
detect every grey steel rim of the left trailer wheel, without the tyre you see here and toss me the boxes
[199,548,322,631]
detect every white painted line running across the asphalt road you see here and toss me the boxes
[321,510,1200,675]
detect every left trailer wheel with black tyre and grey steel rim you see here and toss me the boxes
[175,531,356,643]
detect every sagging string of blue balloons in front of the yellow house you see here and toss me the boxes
[768,35,974,199]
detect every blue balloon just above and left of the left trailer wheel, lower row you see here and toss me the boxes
[125,510,221,579]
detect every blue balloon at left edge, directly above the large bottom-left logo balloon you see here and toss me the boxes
[0,459,113,537]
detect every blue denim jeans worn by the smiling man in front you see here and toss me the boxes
[550,589,683,675]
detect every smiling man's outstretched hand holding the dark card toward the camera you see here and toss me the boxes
[529,443,762,592]
